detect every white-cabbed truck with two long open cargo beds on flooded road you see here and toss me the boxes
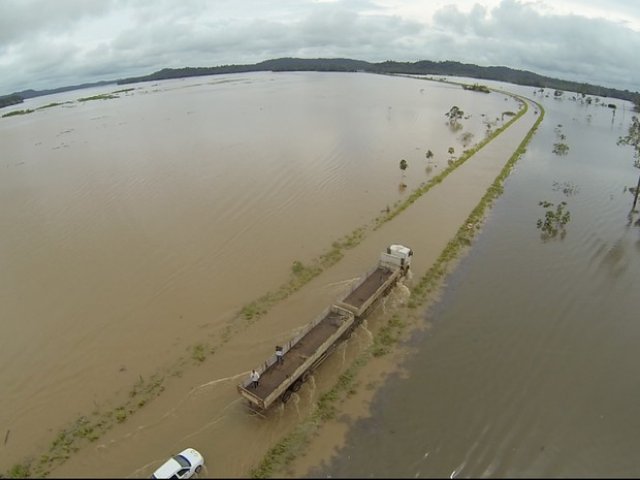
[238,245,413,410]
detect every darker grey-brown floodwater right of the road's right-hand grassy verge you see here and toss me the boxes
[306,82,640,478]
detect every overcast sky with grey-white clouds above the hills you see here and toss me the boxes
[0,0,640,95]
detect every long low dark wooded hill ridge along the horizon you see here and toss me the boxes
[0,58,640,107]
